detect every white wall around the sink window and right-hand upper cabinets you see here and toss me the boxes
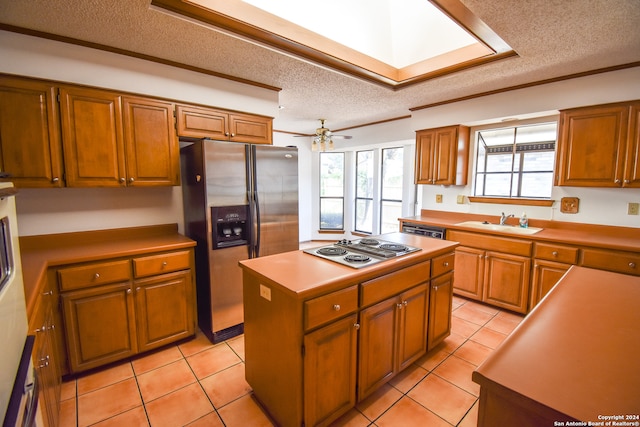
[411,67,640,227]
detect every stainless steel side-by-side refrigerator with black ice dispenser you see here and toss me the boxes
[180,139,299,343]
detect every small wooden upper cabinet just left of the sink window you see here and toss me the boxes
[415,126,469,185]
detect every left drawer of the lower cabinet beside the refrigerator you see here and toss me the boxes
[58,260,131,291]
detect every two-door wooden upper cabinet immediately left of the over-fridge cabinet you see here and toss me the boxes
[60,87,180,187]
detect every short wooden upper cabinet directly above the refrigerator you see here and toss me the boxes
[176,104,273,144]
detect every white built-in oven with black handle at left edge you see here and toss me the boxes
[0,183,38,426]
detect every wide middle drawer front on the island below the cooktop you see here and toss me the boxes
[360,261,431,307]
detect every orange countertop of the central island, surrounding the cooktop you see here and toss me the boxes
[240,233,458,298]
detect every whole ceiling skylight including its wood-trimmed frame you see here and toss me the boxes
[151,0,516,89]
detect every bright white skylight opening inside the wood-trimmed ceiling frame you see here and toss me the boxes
[243,0,478,68]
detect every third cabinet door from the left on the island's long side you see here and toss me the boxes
[395,283,429,372]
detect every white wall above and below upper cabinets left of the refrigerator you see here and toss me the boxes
[0,31,278,236]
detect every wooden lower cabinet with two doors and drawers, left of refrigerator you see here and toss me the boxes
[57,250,195,373]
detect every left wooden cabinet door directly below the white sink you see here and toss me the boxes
[453,246,484,300]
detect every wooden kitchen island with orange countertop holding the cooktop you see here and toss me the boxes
[240,233,457,427]
